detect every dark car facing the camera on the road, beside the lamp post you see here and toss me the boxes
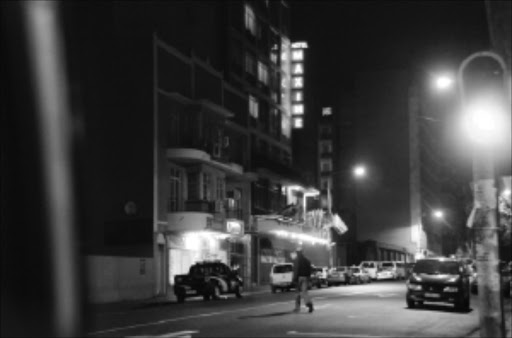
[406,257,470,310]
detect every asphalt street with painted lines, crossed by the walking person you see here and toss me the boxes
[86,281,478,338]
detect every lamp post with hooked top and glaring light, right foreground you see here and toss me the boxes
[457,51,510,337]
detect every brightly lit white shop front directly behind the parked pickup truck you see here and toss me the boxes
[166,212,245,285]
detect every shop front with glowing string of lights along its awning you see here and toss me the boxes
[252,216,331,285]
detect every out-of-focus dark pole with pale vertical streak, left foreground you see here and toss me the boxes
[0,1,83,337]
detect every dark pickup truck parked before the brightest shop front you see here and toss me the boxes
[174,261,243,303]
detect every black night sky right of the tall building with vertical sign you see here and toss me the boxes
[290,1,489,109]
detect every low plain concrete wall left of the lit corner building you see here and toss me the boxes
[87,256,155,303]
